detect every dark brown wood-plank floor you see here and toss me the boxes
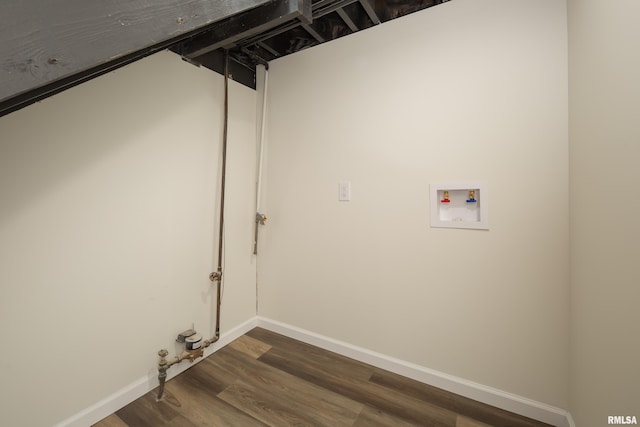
[95,328,547,427]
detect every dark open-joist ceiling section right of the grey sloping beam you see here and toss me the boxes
[171,0,449,88]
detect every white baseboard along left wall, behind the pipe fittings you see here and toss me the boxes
[55,317,258,427]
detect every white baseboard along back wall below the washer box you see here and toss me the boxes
[257,317,575,427]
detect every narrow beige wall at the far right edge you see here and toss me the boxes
[569,0,640,427]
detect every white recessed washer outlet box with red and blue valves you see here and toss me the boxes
[429,181,489,230]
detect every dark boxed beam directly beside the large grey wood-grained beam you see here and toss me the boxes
[179,0,311,59]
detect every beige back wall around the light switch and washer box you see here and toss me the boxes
[258,0,569,408]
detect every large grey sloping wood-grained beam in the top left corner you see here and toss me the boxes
[0,0,270,116]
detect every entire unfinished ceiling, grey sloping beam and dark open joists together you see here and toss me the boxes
[0,0,449,116]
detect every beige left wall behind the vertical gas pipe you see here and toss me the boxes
[0,52,255,426]
